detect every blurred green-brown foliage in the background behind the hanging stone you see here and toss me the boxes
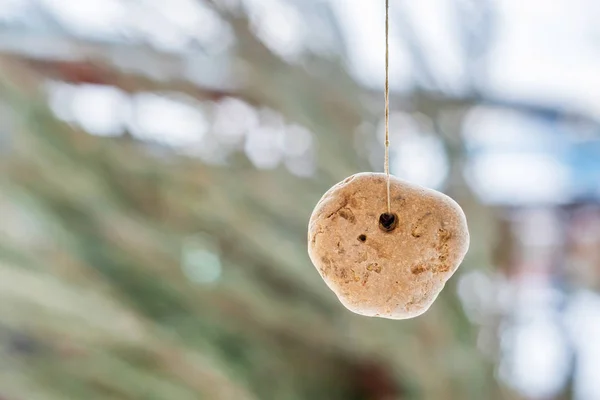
[0,1,528,400]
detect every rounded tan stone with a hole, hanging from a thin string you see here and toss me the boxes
[308,173,469,319]
